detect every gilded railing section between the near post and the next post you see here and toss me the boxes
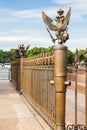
[22,53,55,127]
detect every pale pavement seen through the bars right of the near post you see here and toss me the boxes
[66,89,85,125]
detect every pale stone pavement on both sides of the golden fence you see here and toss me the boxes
[0,80,85,130]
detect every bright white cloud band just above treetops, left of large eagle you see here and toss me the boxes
[0,36,53,50]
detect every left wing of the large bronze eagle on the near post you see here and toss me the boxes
[42,11,58,31]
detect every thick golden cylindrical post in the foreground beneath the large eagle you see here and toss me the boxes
[54,45,67,130]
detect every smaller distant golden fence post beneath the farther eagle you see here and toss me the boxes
[19,58,23,91]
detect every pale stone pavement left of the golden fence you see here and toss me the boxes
[0,80,51,130]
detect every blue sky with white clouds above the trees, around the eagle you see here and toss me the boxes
[0,0,87,51]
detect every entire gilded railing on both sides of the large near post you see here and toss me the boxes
[11,53,87,130]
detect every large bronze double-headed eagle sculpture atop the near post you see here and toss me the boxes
[42,7,71,44]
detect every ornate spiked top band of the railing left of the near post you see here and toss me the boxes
[23,53,54,68]
